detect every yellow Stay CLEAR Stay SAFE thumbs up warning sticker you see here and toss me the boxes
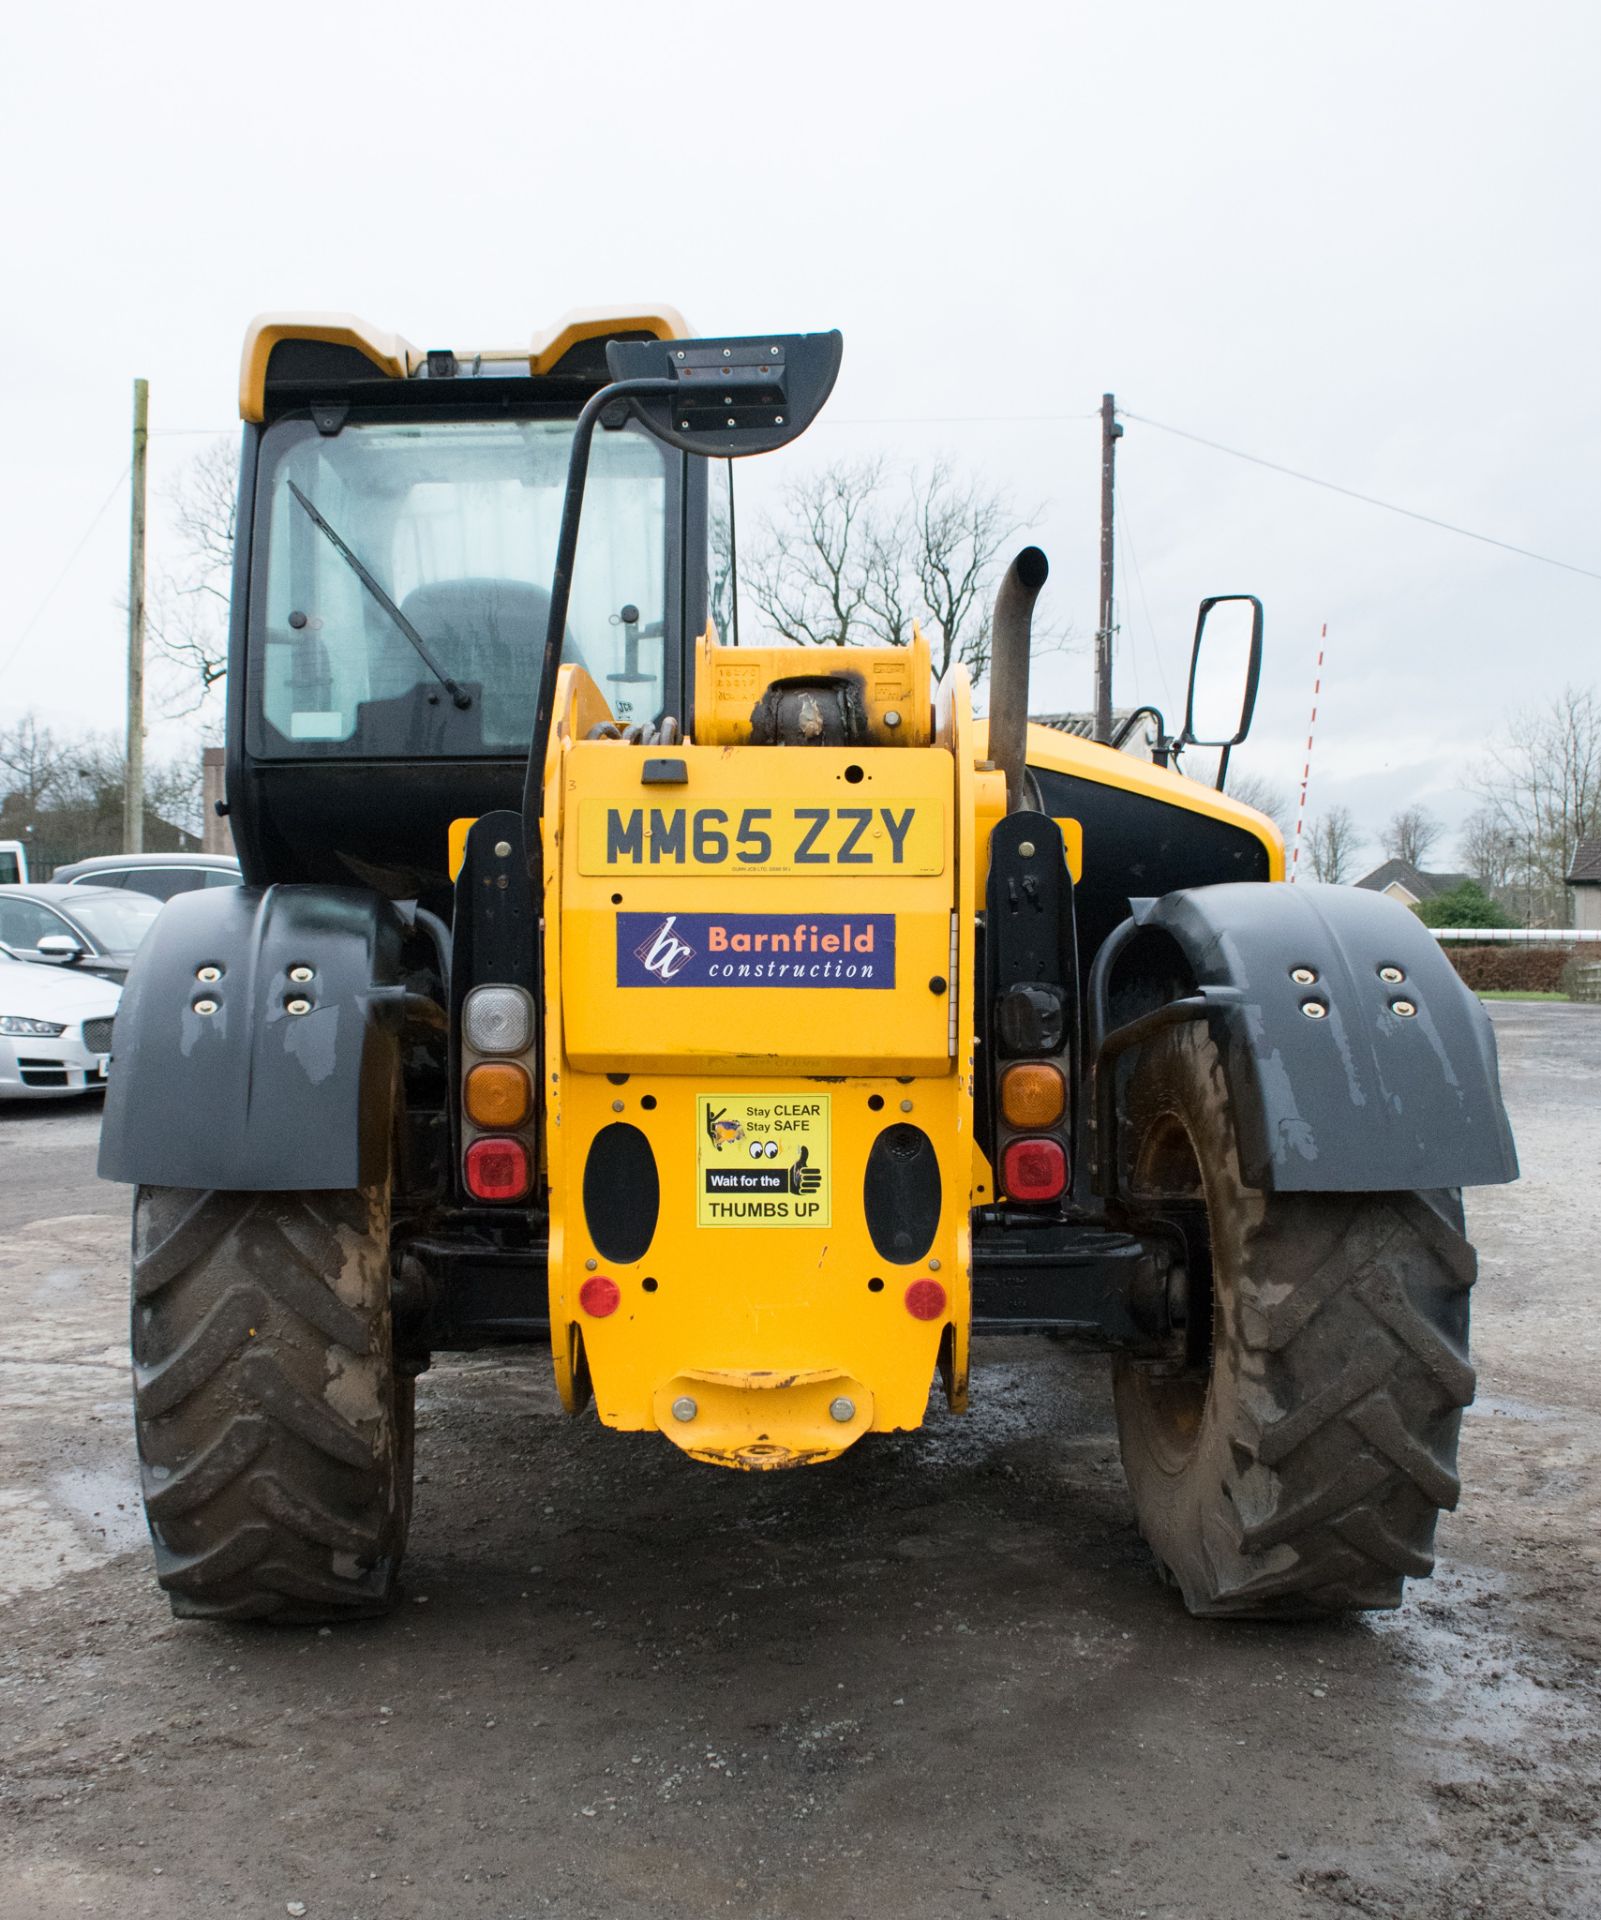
[695,1092,829,1227]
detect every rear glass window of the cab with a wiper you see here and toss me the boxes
[250,419,670,758]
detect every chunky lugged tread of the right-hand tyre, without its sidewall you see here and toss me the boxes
[1119,1029,1476,1619]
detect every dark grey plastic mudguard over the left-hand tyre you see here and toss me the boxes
[100,887,405,1190]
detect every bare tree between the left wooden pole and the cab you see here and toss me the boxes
[148,440,238,714]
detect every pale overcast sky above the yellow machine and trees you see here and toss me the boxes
[0,0,1601,864]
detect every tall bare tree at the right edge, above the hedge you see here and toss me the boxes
[1472,685,1601,927]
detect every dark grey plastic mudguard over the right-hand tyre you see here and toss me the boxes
[1135,883,1518,1192]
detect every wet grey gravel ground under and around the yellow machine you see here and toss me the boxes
[0,1004,1601,1920]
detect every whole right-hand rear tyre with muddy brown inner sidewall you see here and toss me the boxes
[1113,1025,1474,1619]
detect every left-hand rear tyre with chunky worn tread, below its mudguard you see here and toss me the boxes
[132,1187,413,1624]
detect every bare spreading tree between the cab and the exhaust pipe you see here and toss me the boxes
[741,461,1017,678]
